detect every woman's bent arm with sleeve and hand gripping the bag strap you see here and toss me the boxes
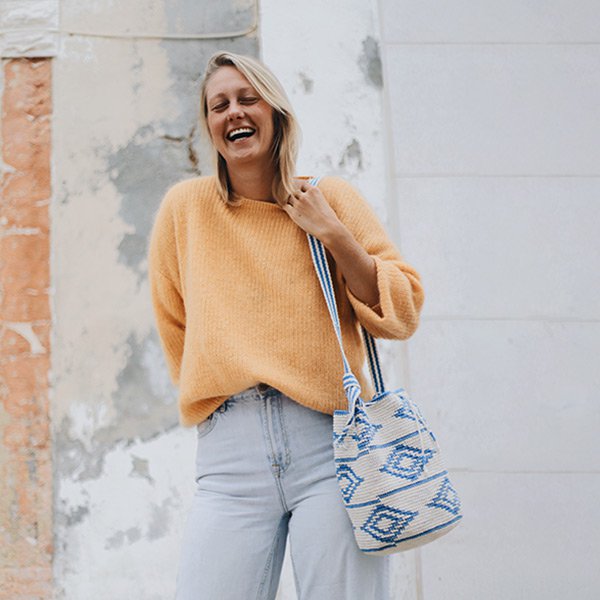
[284,177,425,340]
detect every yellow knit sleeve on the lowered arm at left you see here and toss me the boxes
[148,186,186,386]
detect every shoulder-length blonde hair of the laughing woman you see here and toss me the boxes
[200,52,300,205]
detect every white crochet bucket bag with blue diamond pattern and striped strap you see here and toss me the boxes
[307,178,462,554]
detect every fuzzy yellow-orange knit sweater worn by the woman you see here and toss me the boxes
[148,177,424,426]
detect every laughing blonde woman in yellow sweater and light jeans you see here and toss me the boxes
[149,52,424,600]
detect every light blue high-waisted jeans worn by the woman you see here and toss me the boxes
[176,384,390,600]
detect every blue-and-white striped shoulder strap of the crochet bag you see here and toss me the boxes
[306,177,385,420]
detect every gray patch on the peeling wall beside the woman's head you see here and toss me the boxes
[107,25,258,283]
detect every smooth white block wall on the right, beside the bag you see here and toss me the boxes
[381,0,600,600]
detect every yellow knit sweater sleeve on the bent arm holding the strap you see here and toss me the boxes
[320,177,425,340]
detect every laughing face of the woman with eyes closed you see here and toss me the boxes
[206,66,274,170]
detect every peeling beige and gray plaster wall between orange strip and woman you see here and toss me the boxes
[52,0,258,600]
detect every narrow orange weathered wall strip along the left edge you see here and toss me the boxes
[0,58,53,600]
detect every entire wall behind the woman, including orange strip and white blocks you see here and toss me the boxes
[0,0,600,600]
